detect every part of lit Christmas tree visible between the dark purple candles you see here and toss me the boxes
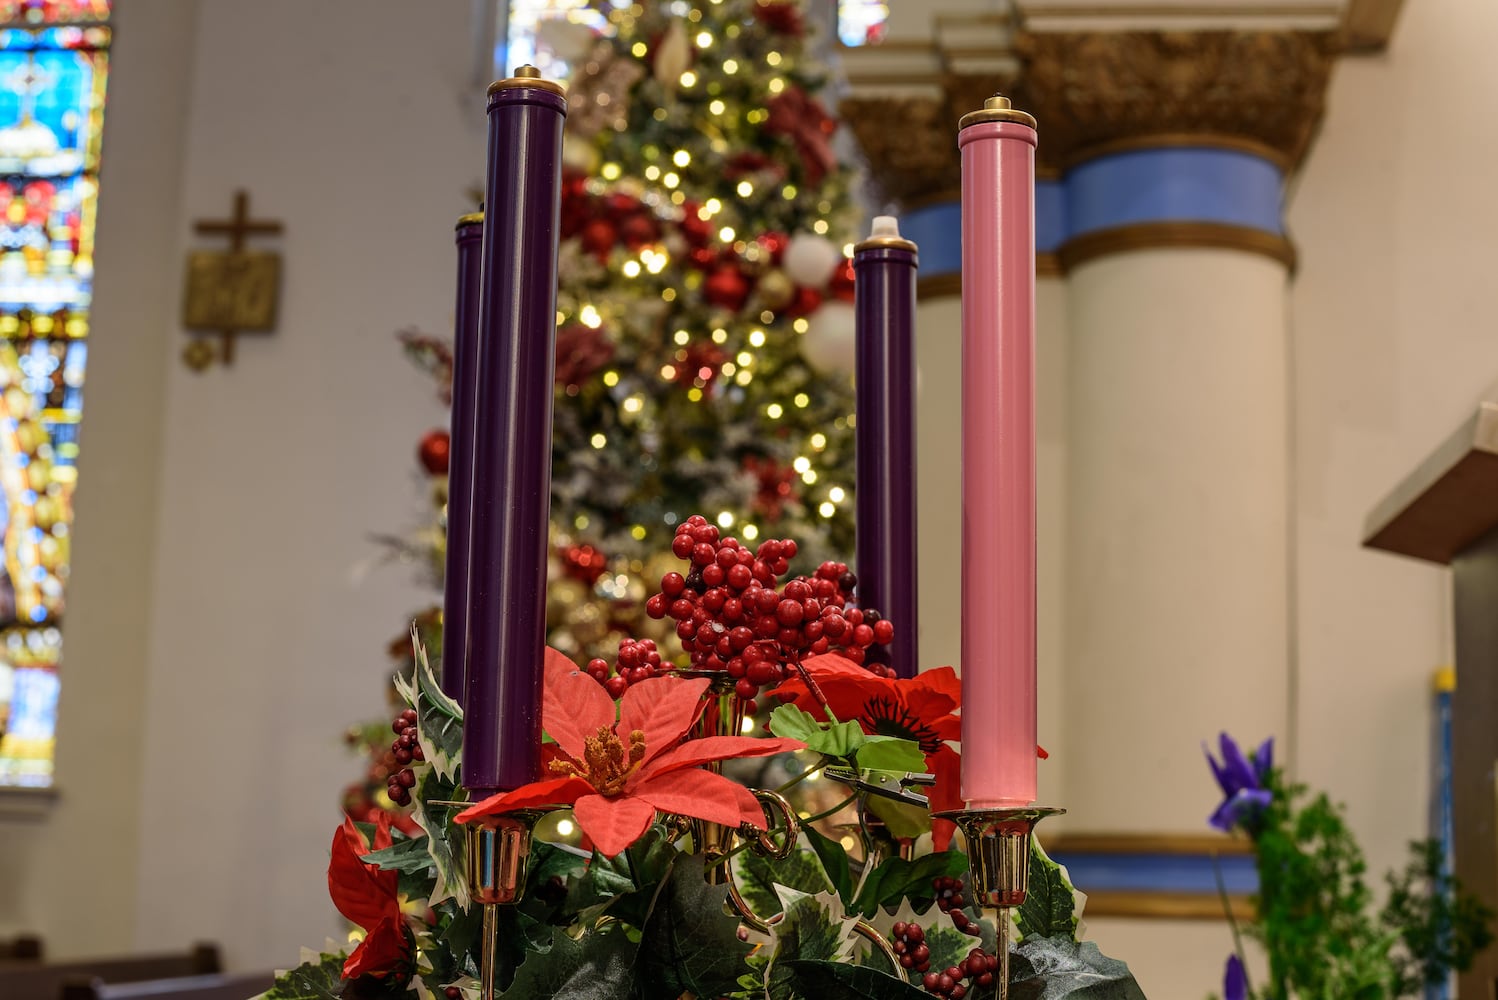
[553,0,854,656]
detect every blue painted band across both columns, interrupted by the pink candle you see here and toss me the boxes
[900,147,1284,278]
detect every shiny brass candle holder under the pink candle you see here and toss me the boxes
[936,805,1067,1000]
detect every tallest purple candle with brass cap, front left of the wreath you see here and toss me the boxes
[463,66,566,795]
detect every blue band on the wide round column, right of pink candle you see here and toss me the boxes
[1065,148,1284,238]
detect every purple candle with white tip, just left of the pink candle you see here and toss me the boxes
[852,216,920,677]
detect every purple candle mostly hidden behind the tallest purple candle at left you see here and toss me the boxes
[442,213,484,705]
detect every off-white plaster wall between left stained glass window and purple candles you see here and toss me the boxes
[125,0,484,967]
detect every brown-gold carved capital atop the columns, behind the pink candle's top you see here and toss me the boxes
[840,30,1342,208]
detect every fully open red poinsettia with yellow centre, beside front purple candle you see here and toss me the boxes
[457,648,803,858]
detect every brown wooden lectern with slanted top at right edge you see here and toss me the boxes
[1363,395,1498,1000]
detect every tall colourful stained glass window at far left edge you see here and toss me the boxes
[0,0,111,787]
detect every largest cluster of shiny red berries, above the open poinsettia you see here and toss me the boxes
[646,515,894,701]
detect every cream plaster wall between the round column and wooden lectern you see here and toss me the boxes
[1288,0,1498,882]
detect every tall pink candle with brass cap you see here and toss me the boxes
[957,97,1035,808]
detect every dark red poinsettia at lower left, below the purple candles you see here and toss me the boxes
[328,813,410,979]
